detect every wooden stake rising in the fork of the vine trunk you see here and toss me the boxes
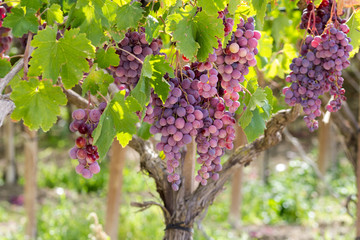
[182,140,196,196]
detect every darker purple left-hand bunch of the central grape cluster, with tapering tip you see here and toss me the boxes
[144,68,204,191]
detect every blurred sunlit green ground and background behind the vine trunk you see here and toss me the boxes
[0,85,358,240]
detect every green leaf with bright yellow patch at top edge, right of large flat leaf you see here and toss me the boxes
[67,0,109,46]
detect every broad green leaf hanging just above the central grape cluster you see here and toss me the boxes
[167,6,224,61]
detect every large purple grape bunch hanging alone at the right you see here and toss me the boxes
[283,0,353,131]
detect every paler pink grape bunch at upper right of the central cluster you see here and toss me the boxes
[215,17,261,113]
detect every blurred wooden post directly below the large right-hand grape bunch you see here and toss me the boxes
[317,121,331,176]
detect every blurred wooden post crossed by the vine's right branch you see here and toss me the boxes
[229,125,247,226]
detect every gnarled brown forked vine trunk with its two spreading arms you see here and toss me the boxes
[129,106,300,240]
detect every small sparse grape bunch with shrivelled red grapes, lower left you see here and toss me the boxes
[69,102,106,178]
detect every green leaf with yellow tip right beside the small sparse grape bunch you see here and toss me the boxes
[93,91,141,158]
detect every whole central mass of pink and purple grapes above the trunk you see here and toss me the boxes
[144,10,261,191]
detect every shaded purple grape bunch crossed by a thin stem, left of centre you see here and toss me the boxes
[110,28,162,94]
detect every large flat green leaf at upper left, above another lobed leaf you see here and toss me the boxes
[29,25,95,89]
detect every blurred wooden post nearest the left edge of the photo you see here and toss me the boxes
[4,118,17,185]
